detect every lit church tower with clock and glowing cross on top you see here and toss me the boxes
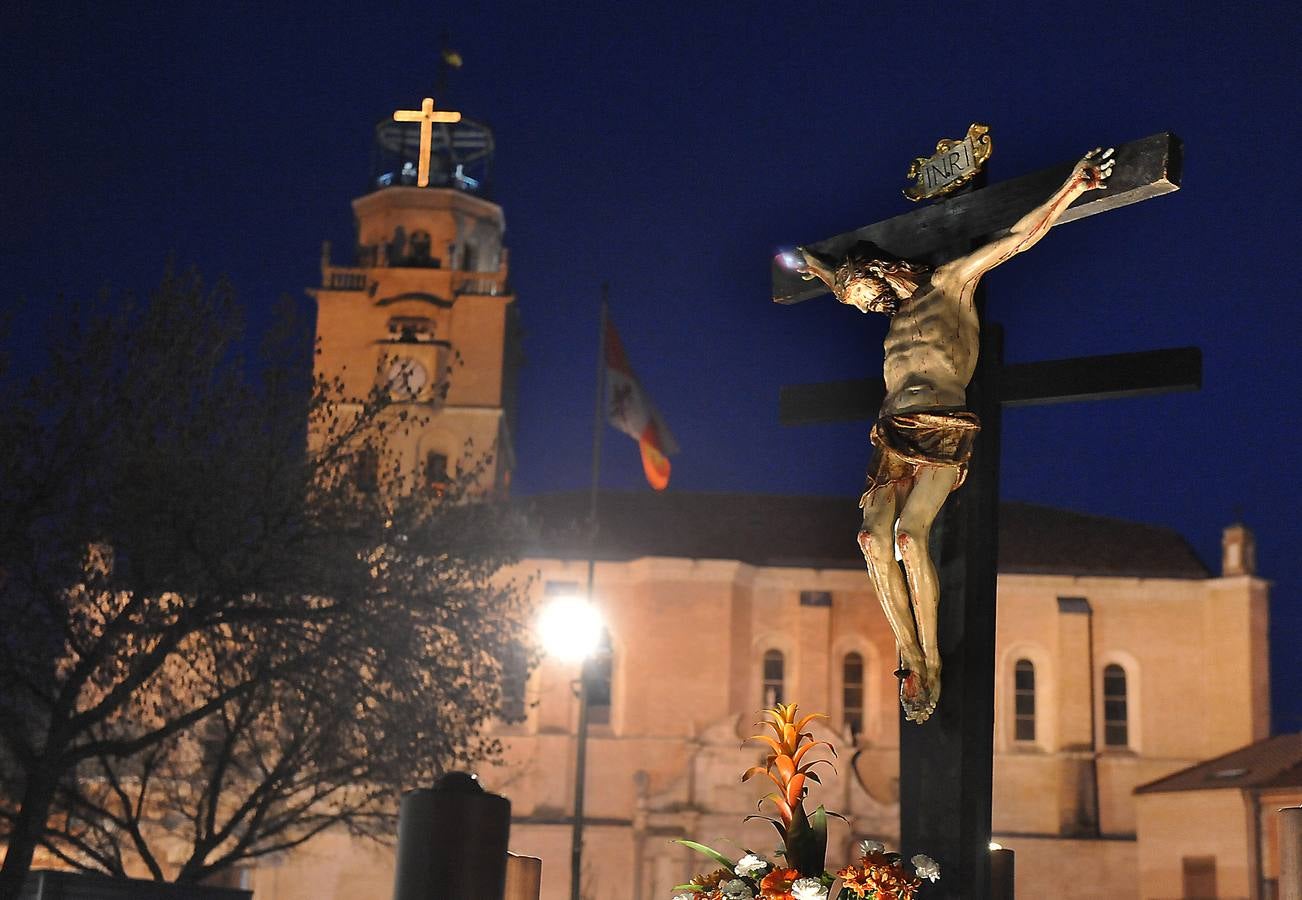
[309,98,518,490]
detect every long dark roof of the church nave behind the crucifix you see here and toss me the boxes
[523,491,1210,578]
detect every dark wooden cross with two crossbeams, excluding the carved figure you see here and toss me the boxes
[773,134,1202,900]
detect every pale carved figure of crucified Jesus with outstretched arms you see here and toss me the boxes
[797,148,1116,723]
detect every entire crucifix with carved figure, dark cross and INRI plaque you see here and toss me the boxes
[773,126,1200,897]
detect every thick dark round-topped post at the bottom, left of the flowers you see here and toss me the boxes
[393,772,510,900]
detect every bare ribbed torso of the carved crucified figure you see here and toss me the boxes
[881,268,979,415]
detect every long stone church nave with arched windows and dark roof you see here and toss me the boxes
[473,494,1269,900]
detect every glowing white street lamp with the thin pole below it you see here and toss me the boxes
[538,590,605,900]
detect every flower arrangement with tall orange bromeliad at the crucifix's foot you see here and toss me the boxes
[673,703,940,900]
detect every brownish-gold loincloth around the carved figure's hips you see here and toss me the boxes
[859,410,980,507]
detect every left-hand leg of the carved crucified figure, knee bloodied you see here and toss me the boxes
[859,483,927,698]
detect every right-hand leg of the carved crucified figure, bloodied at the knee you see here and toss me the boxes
[894,466,958,722]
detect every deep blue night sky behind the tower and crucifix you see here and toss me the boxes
[0,0,1302,731]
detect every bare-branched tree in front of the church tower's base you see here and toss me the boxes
[0,275,529,896]
